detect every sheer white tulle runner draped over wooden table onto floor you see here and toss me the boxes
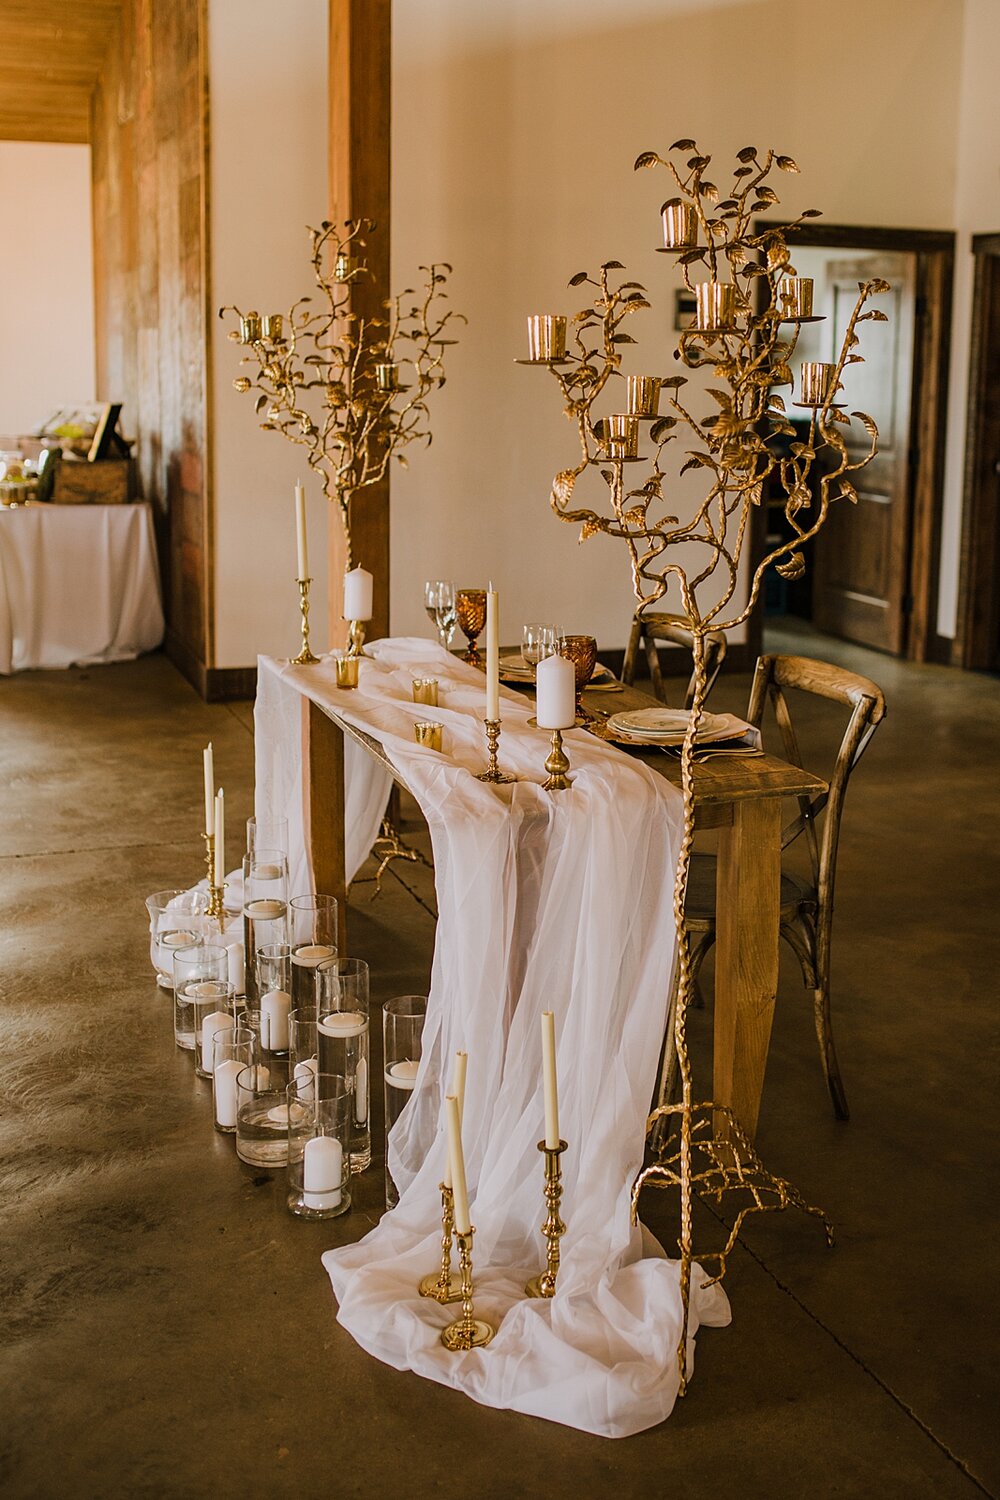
[256,639,729,1437]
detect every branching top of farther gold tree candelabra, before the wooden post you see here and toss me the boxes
[219,219,465,569]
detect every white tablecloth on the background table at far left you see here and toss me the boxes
[0,504,163,675]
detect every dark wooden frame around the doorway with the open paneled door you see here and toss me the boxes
[747,219,955,662]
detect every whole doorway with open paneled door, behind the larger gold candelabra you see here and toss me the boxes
[748,221,955,662]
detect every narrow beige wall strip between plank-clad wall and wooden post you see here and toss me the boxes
[208,0,327,668]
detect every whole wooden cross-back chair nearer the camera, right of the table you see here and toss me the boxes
[660,656,886,1121]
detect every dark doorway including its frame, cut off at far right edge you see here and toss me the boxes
[955,234,1000,672]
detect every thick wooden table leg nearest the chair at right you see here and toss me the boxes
[712,797,781,1140]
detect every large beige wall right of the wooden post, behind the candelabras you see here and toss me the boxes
[393,0,977,647]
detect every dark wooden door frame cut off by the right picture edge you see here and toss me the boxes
[952,234,1000,669]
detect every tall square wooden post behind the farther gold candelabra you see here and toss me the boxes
[328,0,391,645]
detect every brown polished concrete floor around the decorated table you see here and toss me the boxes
[0,627,1000,1500]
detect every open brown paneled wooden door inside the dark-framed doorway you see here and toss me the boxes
[813,254,916,654]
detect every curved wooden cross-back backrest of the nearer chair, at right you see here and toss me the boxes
[747,656,886,923]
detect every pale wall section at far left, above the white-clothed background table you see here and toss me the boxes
[0,141,94,434]
